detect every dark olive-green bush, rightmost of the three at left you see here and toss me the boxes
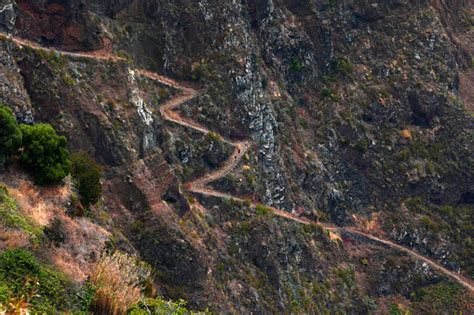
[71,153,102,207]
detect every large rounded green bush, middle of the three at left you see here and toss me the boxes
[20,124,71,184]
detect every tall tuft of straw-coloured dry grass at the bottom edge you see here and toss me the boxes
[91,252,151,315]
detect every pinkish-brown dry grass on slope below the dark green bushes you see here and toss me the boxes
[0,171,110,282]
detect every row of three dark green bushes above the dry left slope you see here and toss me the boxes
[0,106,102,202]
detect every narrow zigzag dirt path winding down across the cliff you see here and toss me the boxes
[0,32,474,293]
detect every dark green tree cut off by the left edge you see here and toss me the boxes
[0,105,23,169]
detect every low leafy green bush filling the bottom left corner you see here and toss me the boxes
[0,249,68,314]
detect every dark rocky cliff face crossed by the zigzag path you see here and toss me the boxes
[0,0,474,313]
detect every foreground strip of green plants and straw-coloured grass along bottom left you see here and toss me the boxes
[0,249,203,315]
